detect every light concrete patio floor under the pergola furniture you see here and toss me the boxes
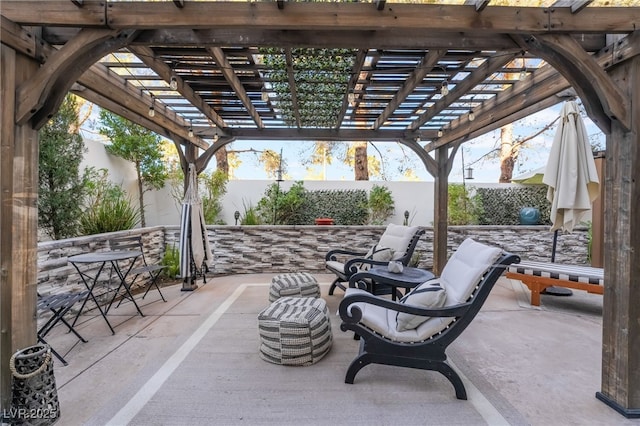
[28,274,640,425]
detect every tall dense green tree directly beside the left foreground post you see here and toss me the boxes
[38,95,87,240]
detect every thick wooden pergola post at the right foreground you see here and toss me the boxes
[596,56,640,417]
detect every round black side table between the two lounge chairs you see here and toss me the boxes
[349,266,435,300]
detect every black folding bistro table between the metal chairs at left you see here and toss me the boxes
[67,250,144,334]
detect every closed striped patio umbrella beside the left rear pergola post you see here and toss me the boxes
[180,164,213,290]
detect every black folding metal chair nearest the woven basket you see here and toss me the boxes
[37,290,89,365]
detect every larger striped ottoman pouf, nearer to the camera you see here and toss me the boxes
[258,297,333,365]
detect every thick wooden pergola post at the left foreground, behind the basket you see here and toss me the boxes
[0,44,38,407]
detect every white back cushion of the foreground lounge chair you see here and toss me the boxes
[440,238,502,306]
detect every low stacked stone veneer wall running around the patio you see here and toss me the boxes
[38,226,588,294]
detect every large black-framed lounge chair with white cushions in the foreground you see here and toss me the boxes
[339,239,520,399]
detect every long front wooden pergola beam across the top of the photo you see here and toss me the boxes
[2,0,640,35]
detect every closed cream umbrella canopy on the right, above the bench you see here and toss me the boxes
[542,101,600,232]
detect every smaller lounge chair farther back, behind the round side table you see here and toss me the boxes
[325,223,424,295]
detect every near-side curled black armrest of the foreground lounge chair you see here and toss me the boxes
[338,292,472,324]
